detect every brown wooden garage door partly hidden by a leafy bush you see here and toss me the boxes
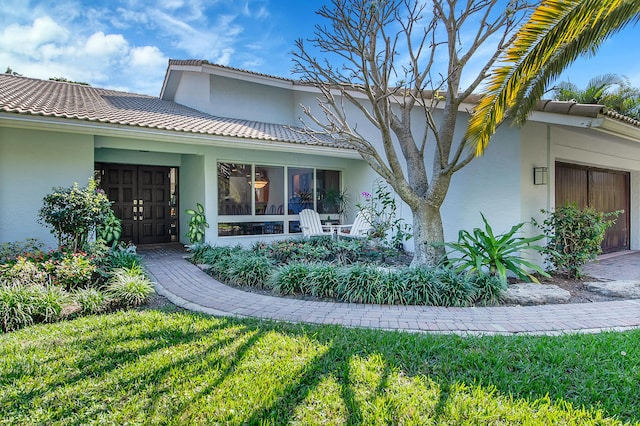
[556,163,630,253]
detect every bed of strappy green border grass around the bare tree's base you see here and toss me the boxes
[191,238,506,306]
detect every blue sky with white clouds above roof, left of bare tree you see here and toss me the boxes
[0,0,296,94]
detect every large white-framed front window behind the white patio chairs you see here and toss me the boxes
[218,163,340,236]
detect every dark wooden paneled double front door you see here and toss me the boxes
[98,164,171,244]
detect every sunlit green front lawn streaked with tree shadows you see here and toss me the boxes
[0,311,640,425]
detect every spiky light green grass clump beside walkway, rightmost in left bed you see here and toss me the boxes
[106,266,154,308]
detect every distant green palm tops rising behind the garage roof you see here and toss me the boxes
[553,74,640,118]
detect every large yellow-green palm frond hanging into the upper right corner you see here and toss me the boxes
[466,0,640,155]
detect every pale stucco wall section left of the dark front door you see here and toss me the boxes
[0,128,93,247]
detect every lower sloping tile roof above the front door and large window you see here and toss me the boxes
[0,74,350,149]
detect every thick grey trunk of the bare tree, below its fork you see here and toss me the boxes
[411,201,445,266]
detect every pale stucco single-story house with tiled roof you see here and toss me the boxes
[0,60,640,255]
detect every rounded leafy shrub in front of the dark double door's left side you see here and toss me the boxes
[38,179,113,252]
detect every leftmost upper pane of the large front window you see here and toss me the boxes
[218,163,251,216]
